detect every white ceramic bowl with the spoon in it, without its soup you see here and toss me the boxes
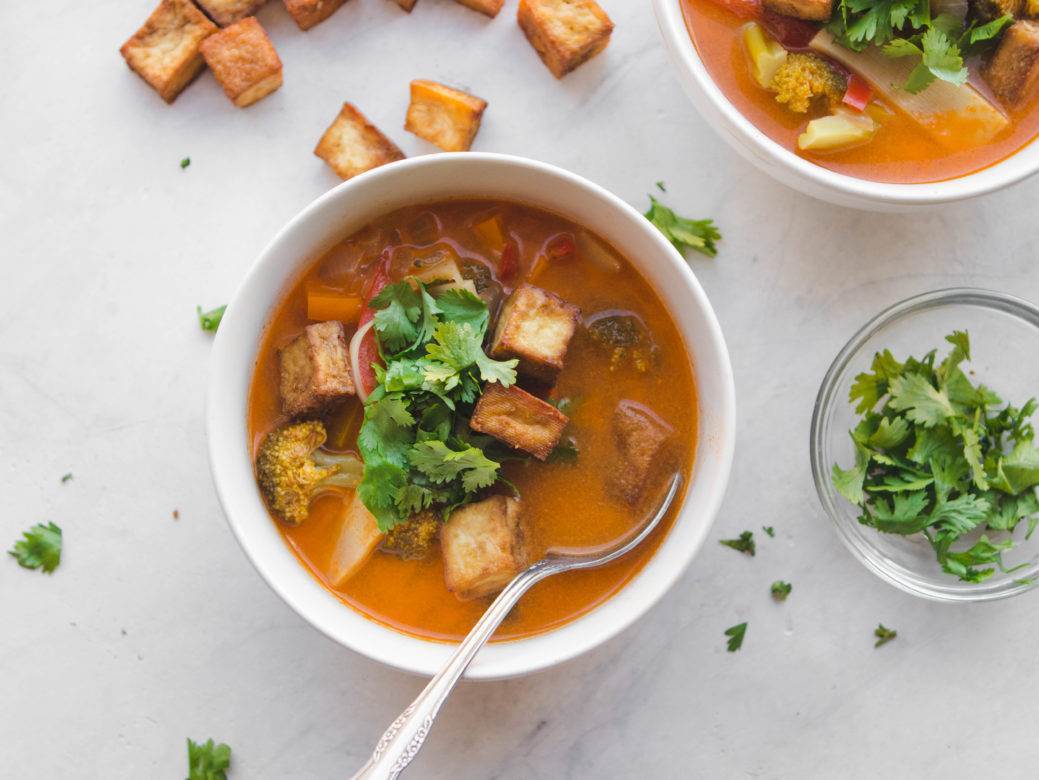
[207,153,736,679]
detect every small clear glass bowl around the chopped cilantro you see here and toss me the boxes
[810,288,1039,601]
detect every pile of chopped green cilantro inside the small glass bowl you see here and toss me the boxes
[832,331,1039,583]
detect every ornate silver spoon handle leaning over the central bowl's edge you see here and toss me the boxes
[352,561,558,780]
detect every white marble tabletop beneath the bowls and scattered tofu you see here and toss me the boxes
[6,0,1039,779]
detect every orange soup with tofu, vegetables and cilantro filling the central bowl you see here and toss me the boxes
[249,200,697,640]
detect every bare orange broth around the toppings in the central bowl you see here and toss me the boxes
[249,200,697,640]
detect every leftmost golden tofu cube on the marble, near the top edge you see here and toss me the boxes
[119,0,217,103]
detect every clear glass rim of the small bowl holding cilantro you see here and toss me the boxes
[808,287,1039,603]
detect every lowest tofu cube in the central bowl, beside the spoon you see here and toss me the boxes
[441,495,530,599]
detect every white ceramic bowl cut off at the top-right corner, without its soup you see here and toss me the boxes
[652,0,1039,211]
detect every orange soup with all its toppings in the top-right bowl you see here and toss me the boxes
[675,0,1039,184]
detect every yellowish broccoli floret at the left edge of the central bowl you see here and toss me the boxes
[257,420,364,526]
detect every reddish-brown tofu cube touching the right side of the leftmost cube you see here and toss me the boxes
[202,17,282,108]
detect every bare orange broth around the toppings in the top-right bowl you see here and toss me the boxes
[675,0,1039,184]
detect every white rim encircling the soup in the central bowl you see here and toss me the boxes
[206,153,736,679]
